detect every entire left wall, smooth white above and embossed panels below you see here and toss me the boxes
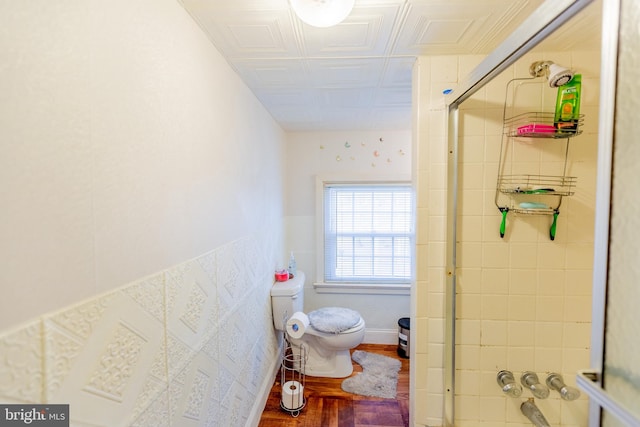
[0,0,285,426]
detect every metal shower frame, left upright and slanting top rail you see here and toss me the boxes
[443,0,605,427]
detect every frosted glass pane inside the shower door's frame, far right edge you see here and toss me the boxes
[603,0,640,426]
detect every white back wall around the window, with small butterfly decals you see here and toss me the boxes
[282,130,411,343]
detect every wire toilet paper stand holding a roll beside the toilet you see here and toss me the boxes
[280,332,307,417]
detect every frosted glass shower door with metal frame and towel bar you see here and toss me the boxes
[578,0,640,427]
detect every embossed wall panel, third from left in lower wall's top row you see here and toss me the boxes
[166,260,218,351]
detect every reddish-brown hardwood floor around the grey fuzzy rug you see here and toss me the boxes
[259,344,409,427]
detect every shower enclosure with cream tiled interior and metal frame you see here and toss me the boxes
[443,0,601,427]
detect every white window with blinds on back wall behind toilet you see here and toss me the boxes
[322,182,414,285]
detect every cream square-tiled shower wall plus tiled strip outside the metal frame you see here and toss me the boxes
[413,48,599,427]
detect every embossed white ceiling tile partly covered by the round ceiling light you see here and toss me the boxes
[301,2,401,57]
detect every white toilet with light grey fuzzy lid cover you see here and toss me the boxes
[271,271,365,378]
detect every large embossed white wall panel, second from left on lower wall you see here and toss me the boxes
[45,284,167,425]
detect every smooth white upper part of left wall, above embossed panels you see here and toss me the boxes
[0,0,283,327]
